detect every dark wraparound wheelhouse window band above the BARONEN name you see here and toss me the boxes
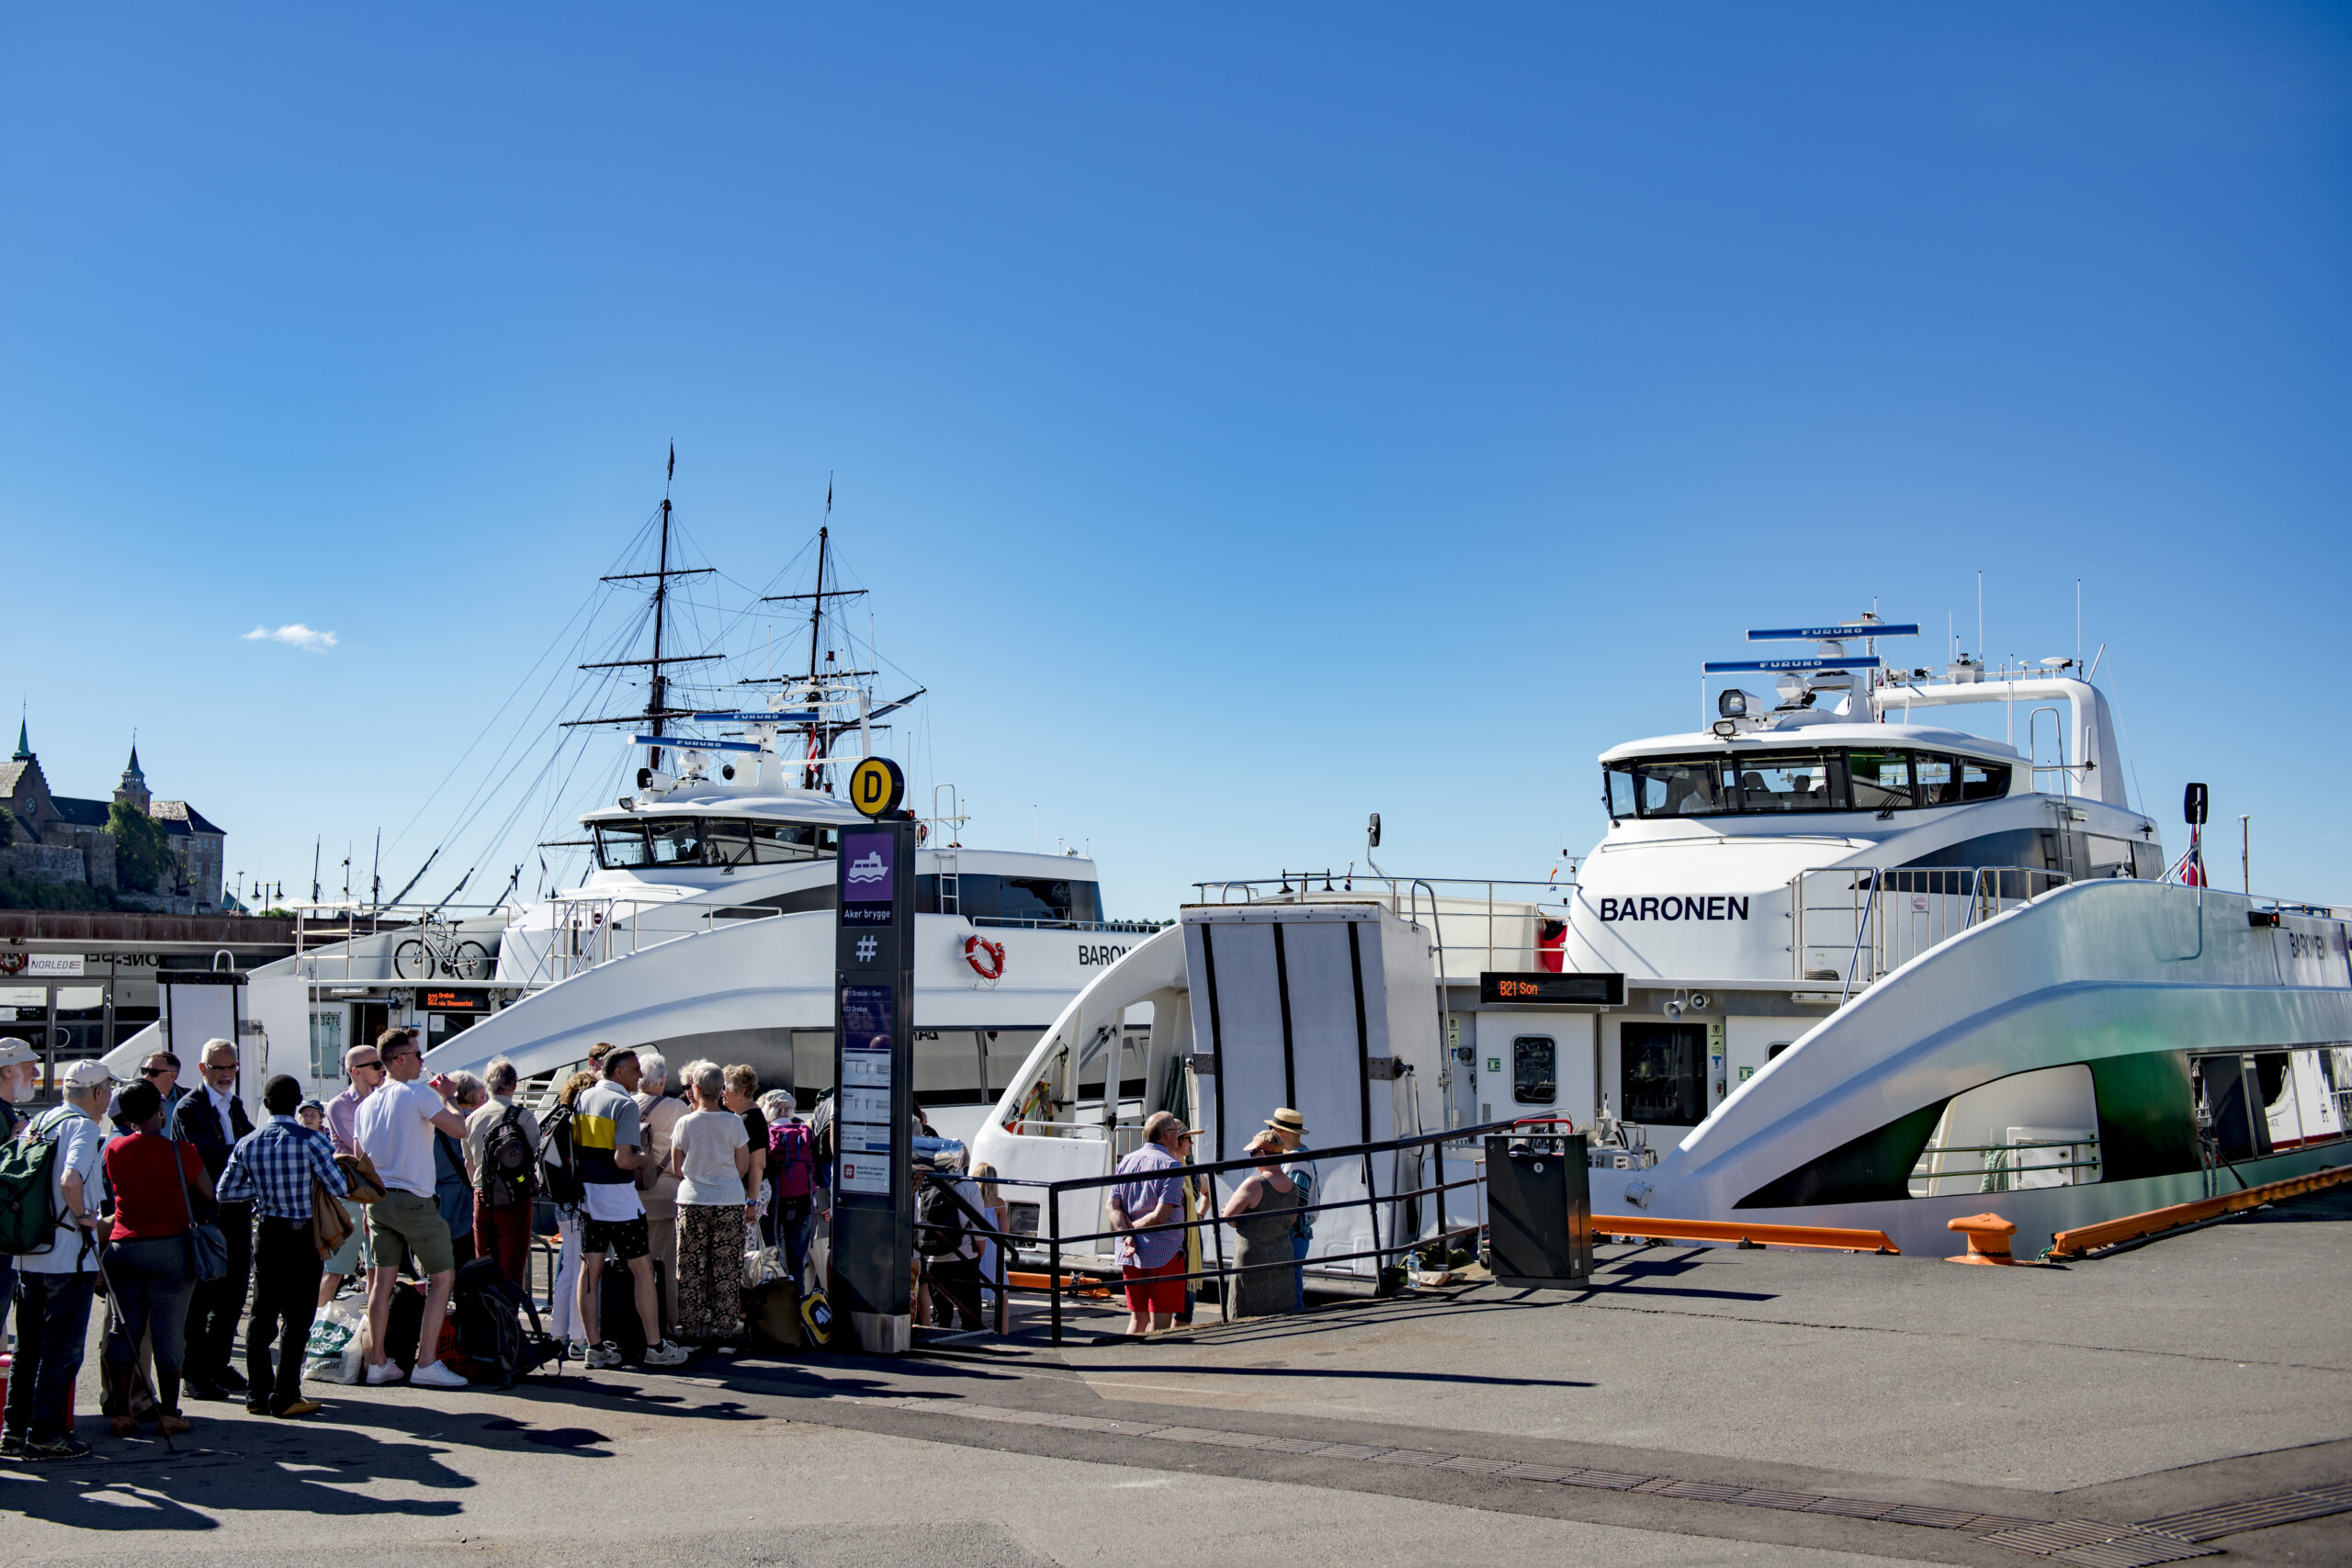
[1604,750,2011,818]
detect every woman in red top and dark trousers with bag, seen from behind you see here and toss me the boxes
[106,1081,211,1437]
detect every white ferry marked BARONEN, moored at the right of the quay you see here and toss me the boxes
[981,616,2352,1256]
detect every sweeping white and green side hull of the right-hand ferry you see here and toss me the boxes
[1592,879,2352,1256]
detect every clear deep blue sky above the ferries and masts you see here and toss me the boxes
[0,5,2352,915]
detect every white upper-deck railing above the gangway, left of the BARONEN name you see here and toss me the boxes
[1193,861,1576,983]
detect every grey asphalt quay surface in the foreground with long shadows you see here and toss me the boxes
[0,1192,2352,1568]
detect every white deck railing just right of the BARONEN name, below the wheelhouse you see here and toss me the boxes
[1790,865,2072,995]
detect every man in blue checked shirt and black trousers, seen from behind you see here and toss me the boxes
[221,1075,350,1416]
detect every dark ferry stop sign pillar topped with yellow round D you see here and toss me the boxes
[832,757,915,1354]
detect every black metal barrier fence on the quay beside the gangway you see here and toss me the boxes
[997,1122,1517,1345]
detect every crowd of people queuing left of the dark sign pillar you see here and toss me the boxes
[0,1030,846,1460]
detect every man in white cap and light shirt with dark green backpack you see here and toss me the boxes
[0,1060,115,1460]
